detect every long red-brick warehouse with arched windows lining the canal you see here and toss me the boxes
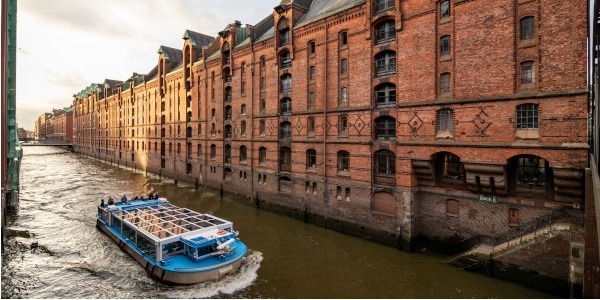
[73,0,588,248]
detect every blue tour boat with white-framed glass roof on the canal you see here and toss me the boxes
[96,198,248,285]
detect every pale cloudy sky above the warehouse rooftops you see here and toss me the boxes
[17,0,280,130]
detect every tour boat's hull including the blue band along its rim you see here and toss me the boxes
[96,219,248,285]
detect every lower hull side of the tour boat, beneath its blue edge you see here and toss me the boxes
[96,220,242,285]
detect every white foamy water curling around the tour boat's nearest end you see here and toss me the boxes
[165,251,263,299]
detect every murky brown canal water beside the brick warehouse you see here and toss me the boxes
[2,147,553,298]
